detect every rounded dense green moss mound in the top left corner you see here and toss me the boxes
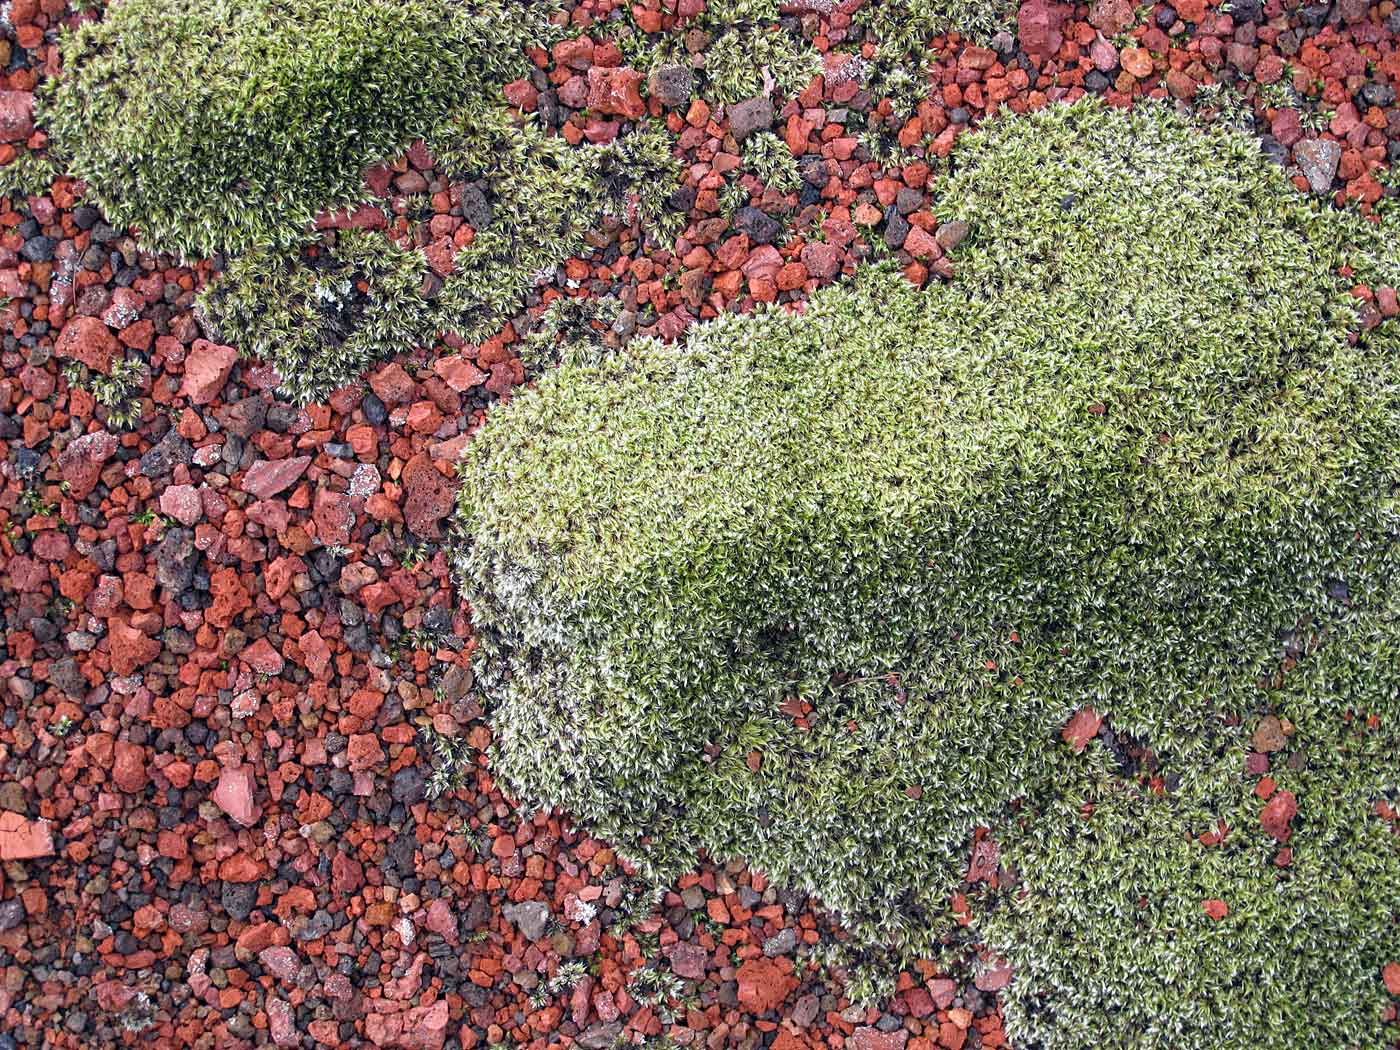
[45,0,556,256]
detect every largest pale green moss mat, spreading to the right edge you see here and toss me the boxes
[459,105,1400,1050]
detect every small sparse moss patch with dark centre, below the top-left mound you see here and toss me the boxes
[199,230,435,403]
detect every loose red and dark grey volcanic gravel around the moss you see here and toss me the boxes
[0,0,1400,1050]
